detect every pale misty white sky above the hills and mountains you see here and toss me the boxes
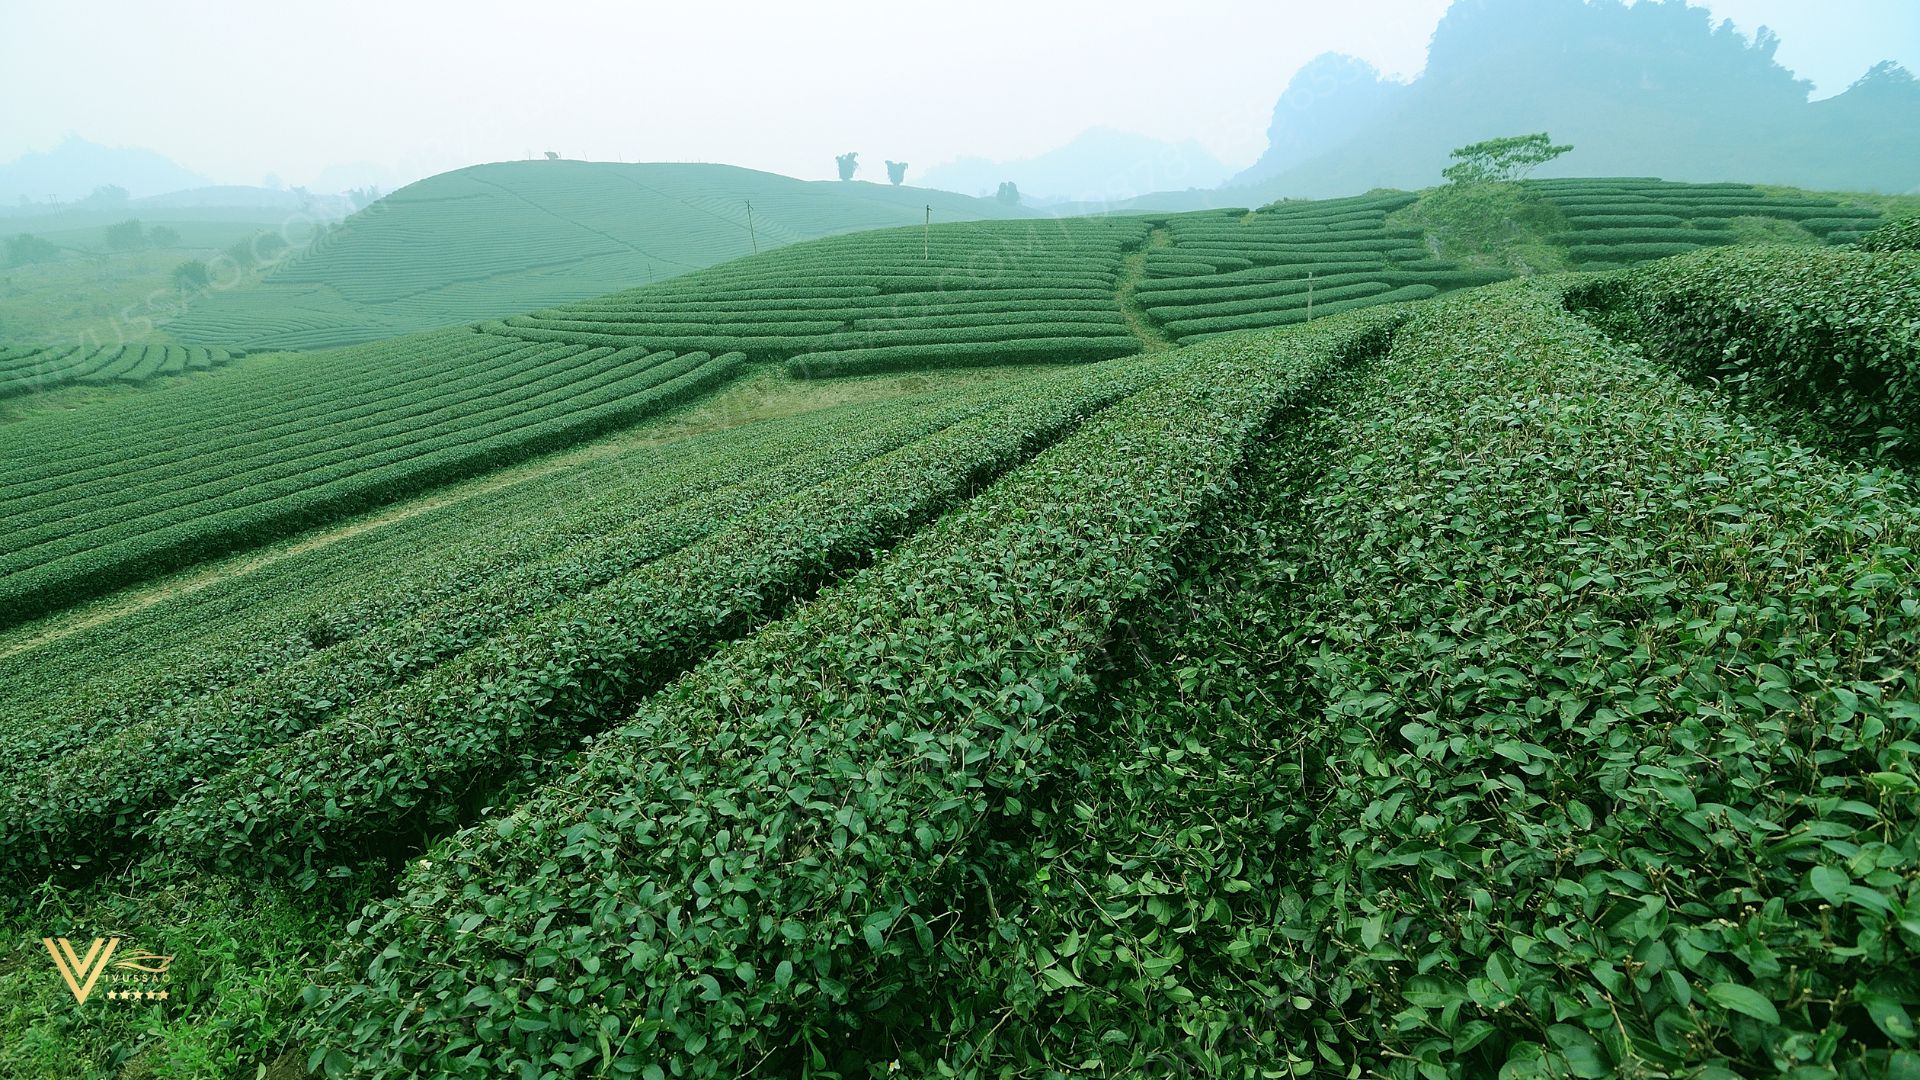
[0,0,1920,184]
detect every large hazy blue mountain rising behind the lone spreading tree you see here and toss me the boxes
[1219,0,1920,204]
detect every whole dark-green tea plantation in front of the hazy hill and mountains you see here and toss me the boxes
[0,181,1920,1078]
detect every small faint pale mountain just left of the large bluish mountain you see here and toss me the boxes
[908,127,1229,206]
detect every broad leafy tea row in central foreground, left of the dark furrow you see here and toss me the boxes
[311,307,1413,1076]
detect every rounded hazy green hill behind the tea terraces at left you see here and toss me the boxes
[167,161,1029,350]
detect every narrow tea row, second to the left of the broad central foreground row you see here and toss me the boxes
[0,382,1052,880]
